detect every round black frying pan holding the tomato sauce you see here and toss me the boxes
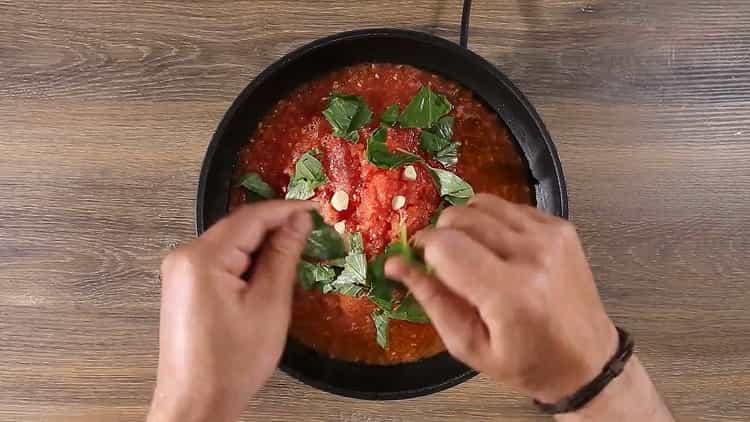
[196,2,568,400]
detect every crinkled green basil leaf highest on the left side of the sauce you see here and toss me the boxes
[323,94,372,143]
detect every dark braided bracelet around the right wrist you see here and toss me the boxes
[534,327,635,414]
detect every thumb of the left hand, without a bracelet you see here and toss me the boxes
[250,211,312,307]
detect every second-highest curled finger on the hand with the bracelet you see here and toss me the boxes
[436,207,527,259]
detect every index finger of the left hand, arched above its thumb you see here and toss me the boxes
[201,200,316,255]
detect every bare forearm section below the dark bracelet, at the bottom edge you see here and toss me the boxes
[555,356,674,422]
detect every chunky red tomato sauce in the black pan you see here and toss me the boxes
[230,64,531,365]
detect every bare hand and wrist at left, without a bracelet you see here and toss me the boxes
[149,201,313,422]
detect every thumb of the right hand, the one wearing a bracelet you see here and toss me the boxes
[385,257,489,366]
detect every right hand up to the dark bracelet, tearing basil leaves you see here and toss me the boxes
[386,194,618,403]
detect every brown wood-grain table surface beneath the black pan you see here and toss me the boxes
[0,0,750,422]
